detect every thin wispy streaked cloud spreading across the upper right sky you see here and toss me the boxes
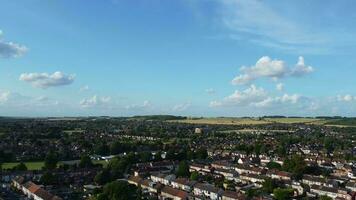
[216,0,356,54]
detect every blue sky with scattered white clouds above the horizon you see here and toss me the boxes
[0,0,356,117]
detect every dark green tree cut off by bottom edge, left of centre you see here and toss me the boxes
[97,181,137,200]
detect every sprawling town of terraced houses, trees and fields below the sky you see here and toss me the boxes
[0,115,356,200]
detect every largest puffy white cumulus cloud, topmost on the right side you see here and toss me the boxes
[231,56,314,85]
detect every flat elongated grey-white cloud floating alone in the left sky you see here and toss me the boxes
[19,71,75,89]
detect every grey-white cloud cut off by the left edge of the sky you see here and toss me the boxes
[0,30,28,58]
